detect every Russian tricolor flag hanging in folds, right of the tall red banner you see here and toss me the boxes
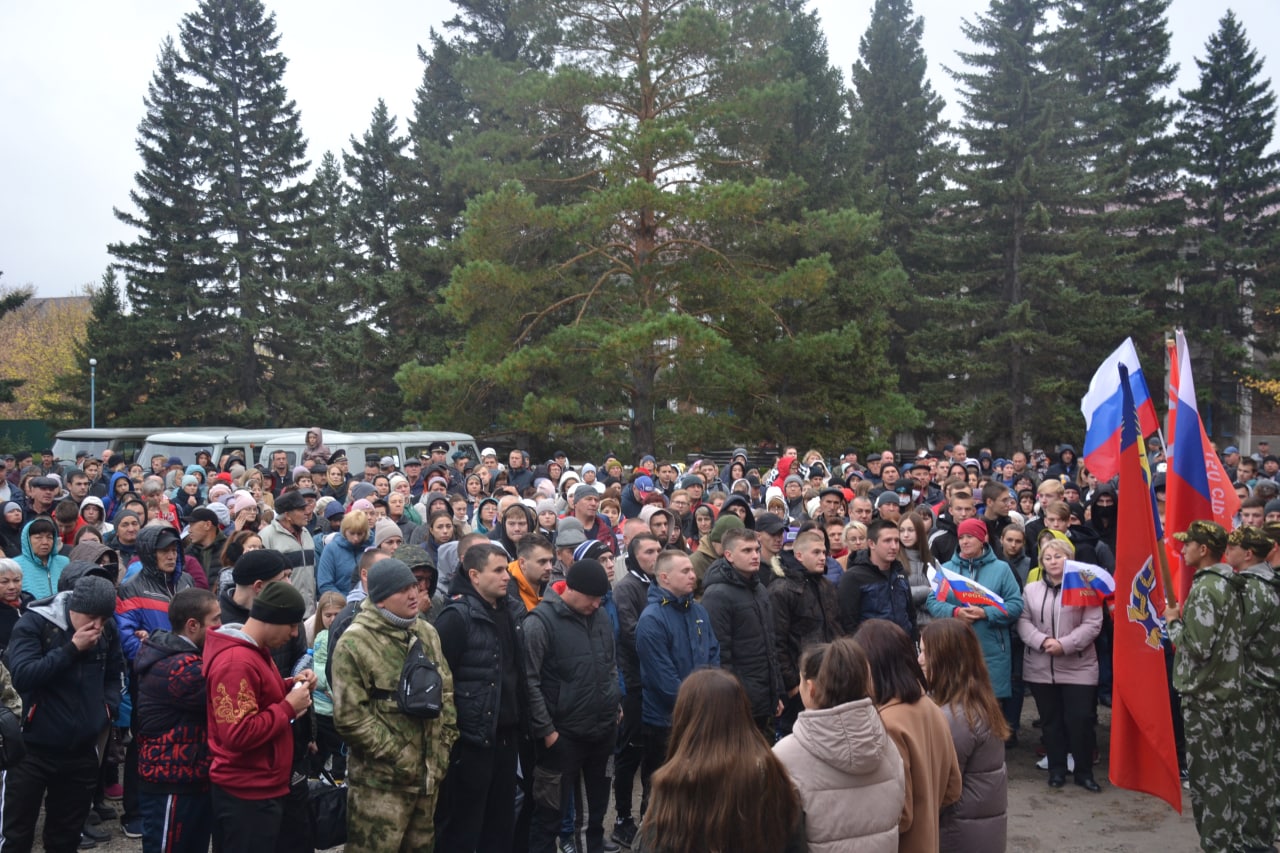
[1165,329,1240,601]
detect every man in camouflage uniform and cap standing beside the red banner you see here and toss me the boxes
[1165,521,1245,853]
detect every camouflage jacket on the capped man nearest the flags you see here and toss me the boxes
[1169,562,1244,703]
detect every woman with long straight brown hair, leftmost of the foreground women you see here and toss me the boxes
[632,670,805,853]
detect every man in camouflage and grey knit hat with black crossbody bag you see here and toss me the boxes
[333,557,458,853]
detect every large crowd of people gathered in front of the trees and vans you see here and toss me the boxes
[0,429,1280,853]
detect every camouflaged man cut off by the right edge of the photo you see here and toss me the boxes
[1228,523,1280,850]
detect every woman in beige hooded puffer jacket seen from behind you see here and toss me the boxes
[773,637,911,853]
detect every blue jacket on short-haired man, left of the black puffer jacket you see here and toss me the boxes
[636,581,719,729]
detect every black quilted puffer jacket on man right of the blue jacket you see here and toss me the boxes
[703,557,783,717]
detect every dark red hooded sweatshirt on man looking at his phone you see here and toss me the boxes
[204,625,293,799]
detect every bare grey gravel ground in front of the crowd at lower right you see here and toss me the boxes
[85,698,1199,853]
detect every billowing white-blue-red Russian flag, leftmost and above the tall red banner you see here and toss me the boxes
[1080,338,1160,480]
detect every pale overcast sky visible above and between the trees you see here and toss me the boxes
[0,0,1280,296]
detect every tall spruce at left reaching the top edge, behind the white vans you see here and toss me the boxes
[179,0,310,423]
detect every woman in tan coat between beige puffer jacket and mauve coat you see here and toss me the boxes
[854,619,963,853]
